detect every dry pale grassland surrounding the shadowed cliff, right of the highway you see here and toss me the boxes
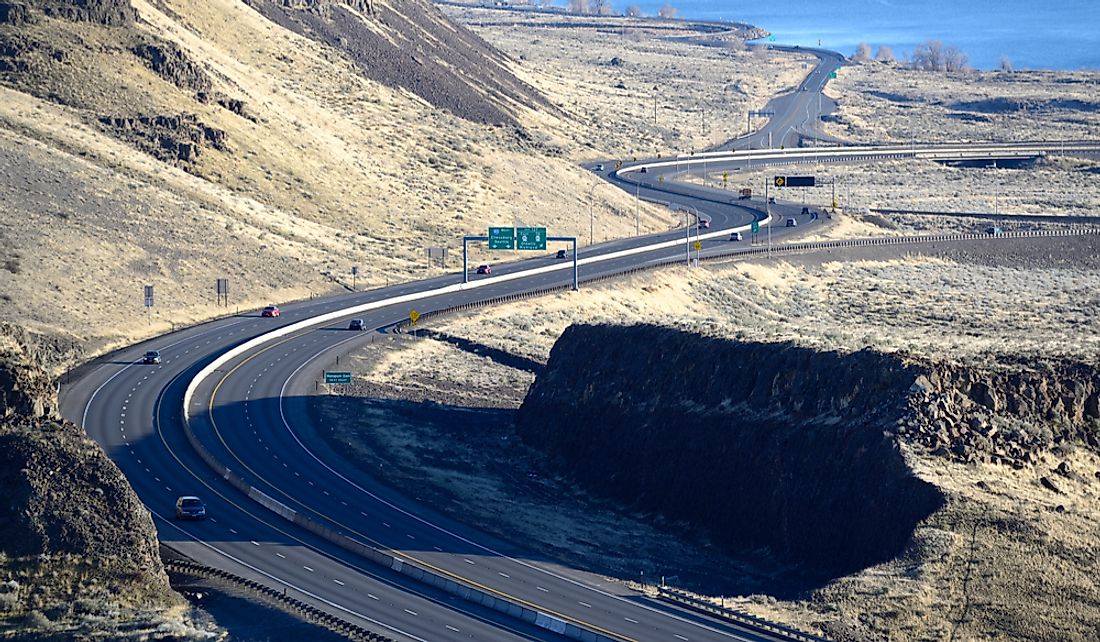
[332,238,1100,642]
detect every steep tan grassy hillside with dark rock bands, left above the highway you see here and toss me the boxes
[0,0,666,352]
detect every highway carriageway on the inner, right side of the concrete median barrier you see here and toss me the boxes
[193,261,800,641]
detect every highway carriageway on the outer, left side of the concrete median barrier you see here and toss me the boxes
[61,202,818,640]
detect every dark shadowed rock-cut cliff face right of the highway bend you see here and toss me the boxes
[517,325,1097,575]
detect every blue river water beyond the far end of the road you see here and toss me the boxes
[629,0,1100,69]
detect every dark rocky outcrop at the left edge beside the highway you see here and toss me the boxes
[0,339,170,604]
